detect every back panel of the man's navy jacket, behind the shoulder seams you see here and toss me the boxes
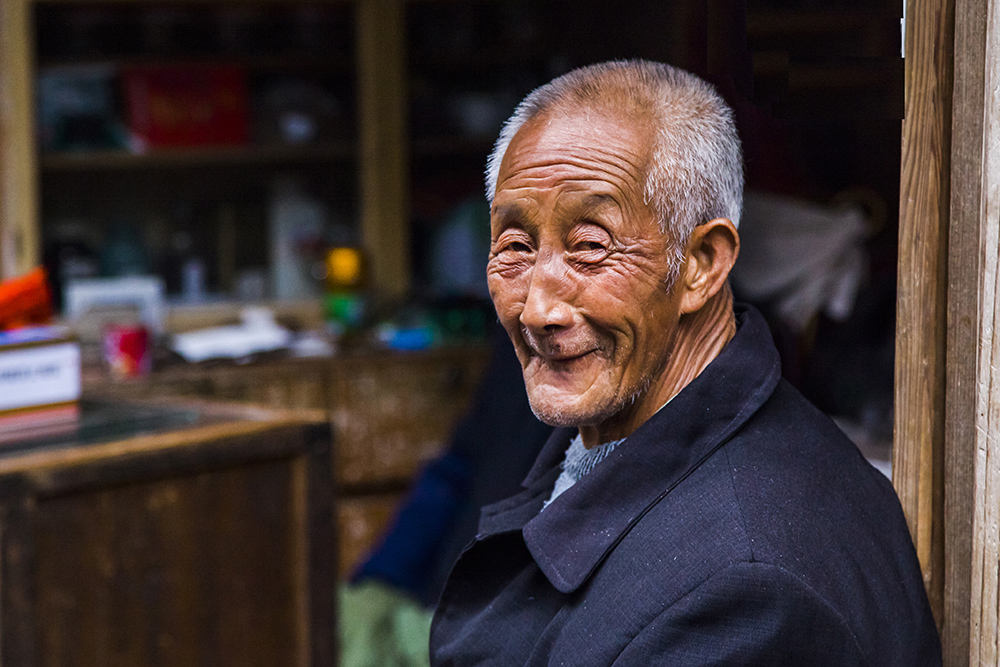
[720,382,940,664]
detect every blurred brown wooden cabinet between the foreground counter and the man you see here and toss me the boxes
[86,347,488,577]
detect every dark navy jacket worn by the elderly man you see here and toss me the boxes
[431,310,941,667]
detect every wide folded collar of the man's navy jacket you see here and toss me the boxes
[480,308,781,593]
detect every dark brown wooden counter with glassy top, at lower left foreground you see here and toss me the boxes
[0,401,336,667]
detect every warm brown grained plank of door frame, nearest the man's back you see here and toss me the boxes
[893,0,954,626]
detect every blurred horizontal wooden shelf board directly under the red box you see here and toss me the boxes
[40,142,356,172]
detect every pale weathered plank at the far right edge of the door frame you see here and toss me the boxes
[970,0,1000,665]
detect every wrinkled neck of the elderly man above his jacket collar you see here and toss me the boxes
[580,283,736,449]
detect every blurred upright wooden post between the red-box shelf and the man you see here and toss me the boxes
[356,0,411,297]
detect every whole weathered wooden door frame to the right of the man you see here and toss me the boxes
[893,0,1000,667]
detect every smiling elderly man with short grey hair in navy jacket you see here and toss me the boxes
[431,61,941,667]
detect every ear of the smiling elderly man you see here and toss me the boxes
[680,218,740,314]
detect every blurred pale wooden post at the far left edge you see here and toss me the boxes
[0,0,41,279]
